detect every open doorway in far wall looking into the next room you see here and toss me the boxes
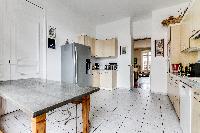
[133,38,151,91]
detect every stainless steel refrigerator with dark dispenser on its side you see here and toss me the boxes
[61,43,91,87]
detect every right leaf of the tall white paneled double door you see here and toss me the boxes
[11,1,42,80]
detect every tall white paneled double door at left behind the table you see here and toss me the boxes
[0,1,46,81]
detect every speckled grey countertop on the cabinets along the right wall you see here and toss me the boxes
[170,73,200,89]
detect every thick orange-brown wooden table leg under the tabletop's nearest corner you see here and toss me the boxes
[32,114,46,133]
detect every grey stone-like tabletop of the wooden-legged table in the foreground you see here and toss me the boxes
[0,79,99,117]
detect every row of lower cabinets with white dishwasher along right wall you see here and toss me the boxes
[168,74,200,133]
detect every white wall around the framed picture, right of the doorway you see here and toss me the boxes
[151,3,188,94]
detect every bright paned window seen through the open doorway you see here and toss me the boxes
[142,51,151,71]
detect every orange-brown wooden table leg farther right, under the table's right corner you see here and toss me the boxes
[82,96,90,133]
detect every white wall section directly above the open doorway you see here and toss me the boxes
[132,18,152,39]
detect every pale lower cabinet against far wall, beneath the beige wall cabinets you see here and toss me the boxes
[100,70,117,90]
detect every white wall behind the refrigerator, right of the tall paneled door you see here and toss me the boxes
[46,0,95,81]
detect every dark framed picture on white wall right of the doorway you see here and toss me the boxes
[155,39,164,57]
